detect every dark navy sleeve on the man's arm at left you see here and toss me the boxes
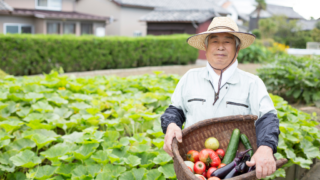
[161,105,186,134]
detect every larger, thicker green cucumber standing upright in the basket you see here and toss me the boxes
[222,129,240,164]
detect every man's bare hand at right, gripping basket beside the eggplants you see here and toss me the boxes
[246,146,276,179]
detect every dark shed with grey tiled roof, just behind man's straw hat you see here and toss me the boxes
[140,0,230,59]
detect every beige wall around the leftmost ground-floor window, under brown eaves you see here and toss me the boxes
[0,15,36,33]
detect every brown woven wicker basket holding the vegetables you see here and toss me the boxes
[172,115,287,180]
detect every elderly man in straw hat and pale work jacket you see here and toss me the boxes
[161,17,280,178]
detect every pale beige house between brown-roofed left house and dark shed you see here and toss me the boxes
[75,0,171,37]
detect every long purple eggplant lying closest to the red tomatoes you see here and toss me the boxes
[210,149,251,179]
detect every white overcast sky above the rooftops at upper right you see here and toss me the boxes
[231,0,320,19]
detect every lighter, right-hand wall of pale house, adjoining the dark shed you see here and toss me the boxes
[119,7,152,36]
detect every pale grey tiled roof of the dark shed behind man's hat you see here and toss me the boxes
[140,0,230,22]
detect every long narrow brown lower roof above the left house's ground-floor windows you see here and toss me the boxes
[0,8,109,20]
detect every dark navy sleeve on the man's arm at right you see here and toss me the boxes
[256,113,280,154]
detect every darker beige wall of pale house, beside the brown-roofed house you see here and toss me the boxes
[75,0,121,35]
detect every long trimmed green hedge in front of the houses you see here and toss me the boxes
[0,34,198,75]
